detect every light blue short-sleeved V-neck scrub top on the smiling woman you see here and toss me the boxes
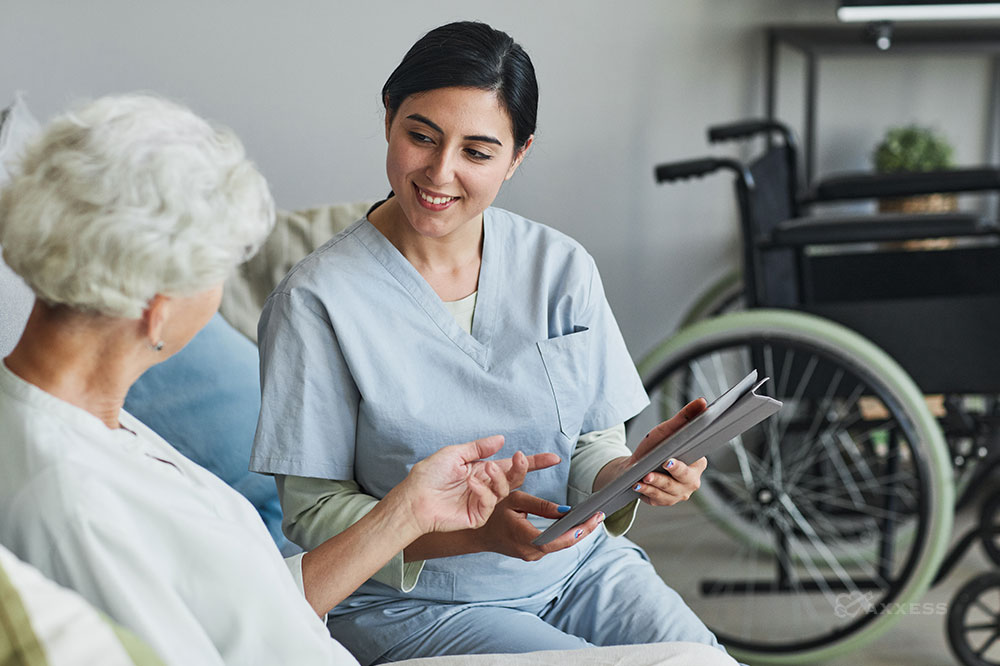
[250,208,648,604]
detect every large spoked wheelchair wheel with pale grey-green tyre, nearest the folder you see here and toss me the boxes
[633,310,954,663]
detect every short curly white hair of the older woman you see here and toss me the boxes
[0,94,274,319]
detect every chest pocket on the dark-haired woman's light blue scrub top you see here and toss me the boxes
[535,326,593,439]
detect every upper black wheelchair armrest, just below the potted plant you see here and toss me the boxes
[804,167,1000,203]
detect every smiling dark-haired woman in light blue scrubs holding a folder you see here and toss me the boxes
[251,18,717,664]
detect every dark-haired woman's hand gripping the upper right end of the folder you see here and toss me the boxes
[594,398,708,506]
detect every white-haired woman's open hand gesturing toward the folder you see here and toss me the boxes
[399,435,559,534]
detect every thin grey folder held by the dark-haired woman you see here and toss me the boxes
[531,370,781,546]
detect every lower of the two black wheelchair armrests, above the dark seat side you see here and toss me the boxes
[761,213,1000,248]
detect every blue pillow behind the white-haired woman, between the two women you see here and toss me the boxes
[125,314,294,551]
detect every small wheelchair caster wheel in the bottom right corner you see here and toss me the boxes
[948,572,1000,666]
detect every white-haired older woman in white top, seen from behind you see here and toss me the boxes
[0,95,555,664]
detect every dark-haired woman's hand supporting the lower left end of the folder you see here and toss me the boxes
[477,491,604,562]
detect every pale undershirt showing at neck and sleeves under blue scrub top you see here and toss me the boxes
[275,293,638,592]
